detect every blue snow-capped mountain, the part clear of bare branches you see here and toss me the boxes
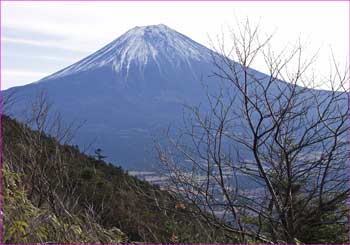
[3,25,223,170]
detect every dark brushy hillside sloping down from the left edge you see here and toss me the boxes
[2,116,236,243]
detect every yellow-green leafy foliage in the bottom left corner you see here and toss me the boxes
[2,161,126,243]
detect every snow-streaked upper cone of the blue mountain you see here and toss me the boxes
[42,24,211,80]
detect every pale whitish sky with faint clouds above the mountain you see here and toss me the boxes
[1,2,349,89]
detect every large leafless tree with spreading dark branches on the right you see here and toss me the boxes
[158,21,349,243]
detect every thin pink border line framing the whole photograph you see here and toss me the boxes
[0,0,350,245]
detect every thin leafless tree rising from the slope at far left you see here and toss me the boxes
[3,90,81,215]
